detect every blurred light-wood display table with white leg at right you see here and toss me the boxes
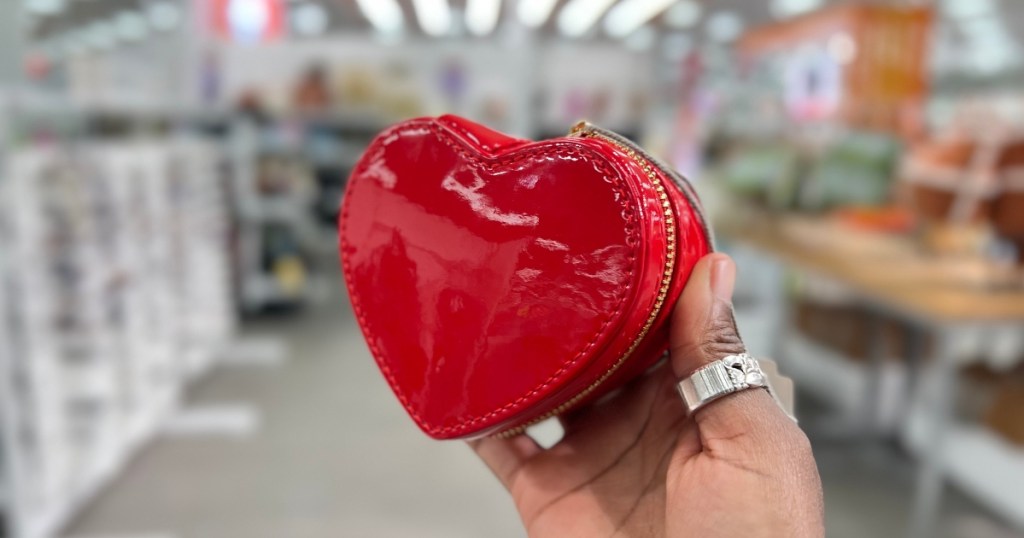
[715,217,1024,538]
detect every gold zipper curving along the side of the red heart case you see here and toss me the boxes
[494,122,676,439]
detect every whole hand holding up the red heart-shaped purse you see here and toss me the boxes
[471,254,824,538]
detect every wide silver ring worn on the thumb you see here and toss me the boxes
[677,354,796,420]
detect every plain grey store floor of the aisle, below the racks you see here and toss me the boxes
[68,282,1016,538]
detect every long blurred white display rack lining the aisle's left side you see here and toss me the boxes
[0,102,236,538]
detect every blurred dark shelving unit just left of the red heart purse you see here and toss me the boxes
[229,114,385,313]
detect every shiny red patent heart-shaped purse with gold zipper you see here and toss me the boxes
[339,116,712,439]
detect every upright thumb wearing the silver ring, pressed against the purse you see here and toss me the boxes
[670,254,788,441]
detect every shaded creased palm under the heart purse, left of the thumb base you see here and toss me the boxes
[510,367,686,537]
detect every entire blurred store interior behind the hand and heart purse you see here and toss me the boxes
[0,0,1024,538]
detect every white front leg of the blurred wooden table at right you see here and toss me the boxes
[909,329,957,538]
